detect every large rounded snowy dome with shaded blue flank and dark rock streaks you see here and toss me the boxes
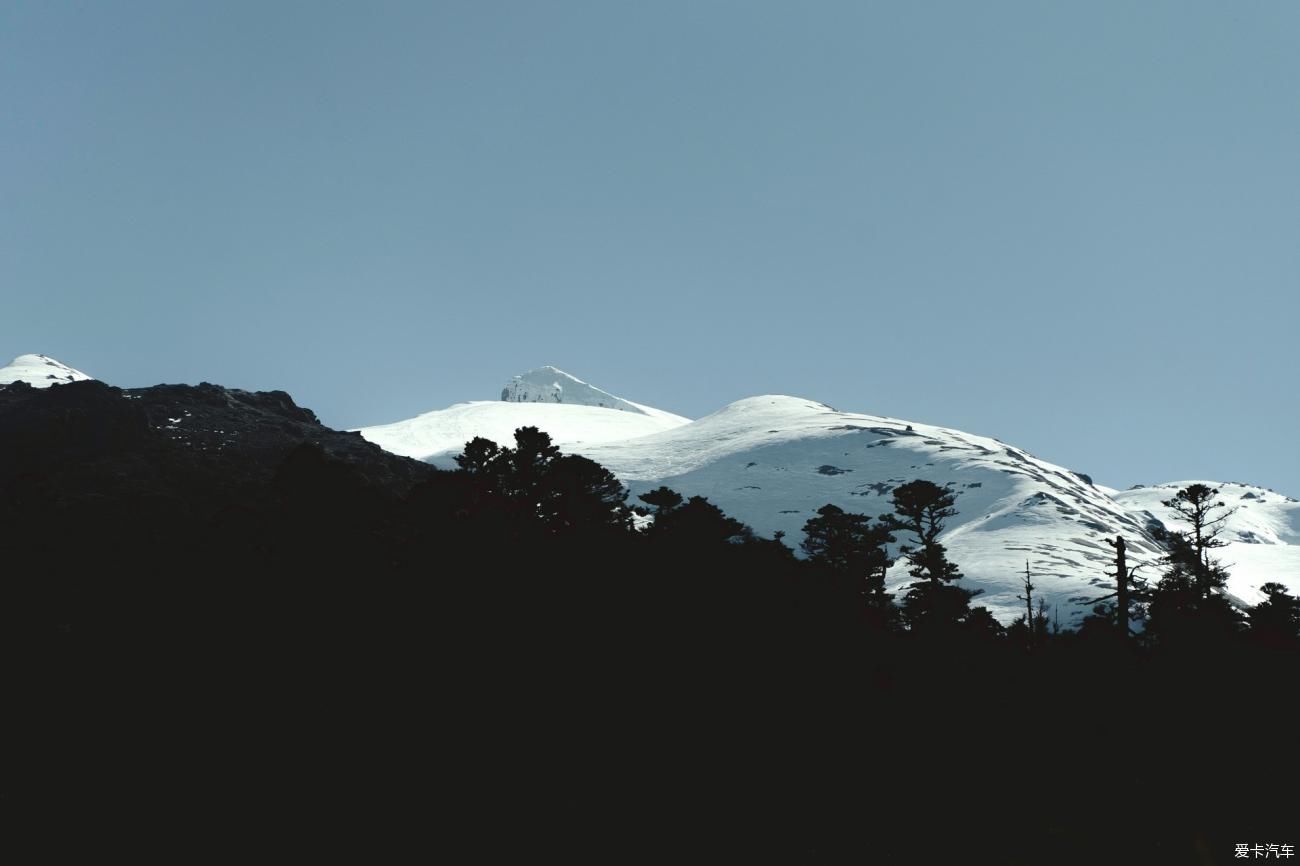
[581,395,1156,623]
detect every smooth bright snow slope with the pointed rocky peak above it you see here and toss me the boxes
[359,367,690,468]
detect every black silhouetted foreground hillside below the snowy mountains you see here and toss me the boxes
[0,382,1300,863]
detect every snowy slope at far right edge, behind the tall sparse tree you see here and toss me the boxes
[1113,481,1300,605]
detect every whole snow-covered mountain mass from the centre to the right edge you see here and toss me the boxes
[360,368,1300,624]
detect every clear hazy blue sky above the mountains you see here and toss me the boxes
[0,0,1300,495]
